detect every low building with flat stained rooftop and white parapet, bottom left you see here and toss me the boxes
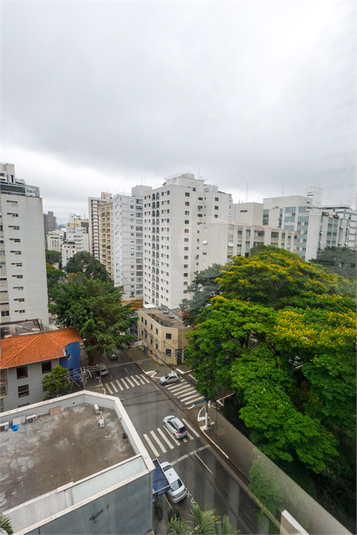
[0,390,155,535]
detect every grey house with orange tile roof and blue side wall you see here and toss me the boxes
[0,328,82,412]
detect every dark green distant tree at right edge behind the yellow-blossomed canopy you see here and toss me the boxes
[310,247,357,280]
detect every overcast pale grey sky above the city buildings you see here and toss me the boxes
[0,0,355,223]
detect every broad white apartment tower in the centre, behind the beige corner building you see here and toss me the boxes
[144,173,232,309]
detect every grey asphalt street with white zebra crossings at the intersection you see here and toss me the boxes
[98,352,261,533]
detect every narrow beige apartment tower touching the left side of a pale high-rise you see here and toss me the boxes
[98,201,114,281]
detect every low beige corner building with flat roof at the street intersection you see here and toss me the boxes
[138,306,192,366]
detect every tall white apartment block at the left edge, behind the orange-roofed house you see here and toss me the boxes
[0,164,48,325]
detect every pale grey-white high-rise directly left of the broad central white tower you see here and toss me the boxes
[113,186,152,299]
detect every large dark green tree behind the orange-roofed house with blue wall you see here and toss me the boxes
[49,277,136,365]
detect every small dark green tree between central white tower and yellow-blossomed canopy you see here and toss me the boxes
[180,264,223,325]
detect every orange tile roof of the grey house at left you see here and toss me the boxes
[0,328,82,369]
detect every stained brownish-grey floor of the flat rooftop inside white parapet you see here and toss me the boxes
[0,404,135,511]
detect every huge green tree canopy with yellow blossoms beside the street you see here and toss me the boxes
[185,247,356,528]
